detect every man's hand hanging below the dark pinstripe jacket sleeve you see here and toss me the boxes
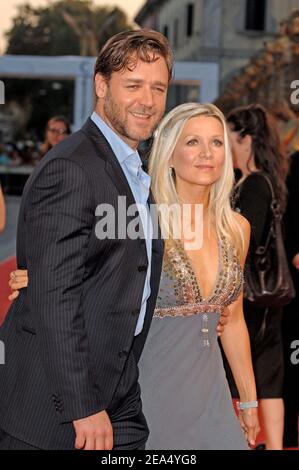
[73,411,113,450]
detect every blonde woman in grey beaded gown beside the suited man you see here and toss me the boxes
[8,103,259,450]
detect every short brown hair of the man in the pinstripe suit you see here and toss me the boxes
[94,29,173,80]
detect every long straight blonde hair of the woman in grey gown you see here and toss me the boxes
[149,103,244,257]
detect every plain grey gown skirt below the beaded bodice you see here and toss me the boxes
[139,313,249,450]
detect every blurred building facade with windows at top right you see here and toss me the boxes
[135,0,298,90]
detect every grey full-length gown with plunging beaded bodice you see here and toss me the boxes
[139,238,248,450]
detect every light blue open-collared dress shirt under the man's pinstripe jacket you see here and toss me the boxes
[91,112,153,336]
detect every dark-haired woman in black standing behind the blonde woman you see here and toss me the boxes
[228,105,287,450]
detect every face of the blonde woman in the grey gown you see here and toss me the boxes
[171,116,225,186]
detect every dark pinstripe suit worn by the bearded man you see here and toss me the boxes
[0,120,163,449]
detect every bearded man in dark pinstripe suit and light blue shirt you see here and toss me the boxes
[0,30,172,449]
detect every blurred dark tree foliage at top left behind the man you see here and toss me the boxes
[6,0,131,55]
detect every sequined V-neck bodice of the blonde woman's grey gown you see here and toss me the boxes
[154,237,243,317]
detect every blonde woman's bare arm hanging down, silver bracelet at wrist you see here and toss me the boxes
[221,214,259,445]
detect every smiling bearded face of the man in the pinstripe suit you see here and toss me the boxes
[95,56,168,149]
